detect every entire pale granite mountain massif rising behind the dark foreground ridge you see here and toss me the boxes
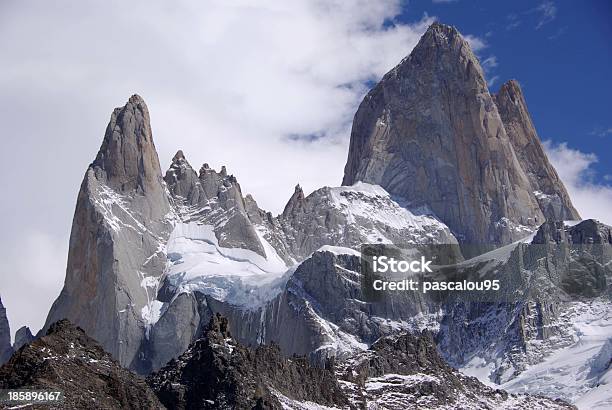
[0,19,612,408]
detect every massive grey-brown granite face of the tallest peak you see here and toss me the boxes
[343,23,573,244]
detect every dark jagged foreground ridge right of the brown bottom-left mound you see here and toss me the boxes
[147,315,573,409]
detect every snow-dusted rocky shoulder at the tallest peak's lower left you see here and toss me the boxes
[273,182,457,260]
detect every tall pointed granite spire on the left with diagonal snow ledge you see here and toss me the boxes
[41,95,171,372]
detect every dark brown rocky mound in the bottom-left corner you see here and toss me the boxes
[0,320,163,409]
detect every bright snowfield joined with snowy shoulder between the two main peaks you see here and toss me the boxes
[160,181,455,307]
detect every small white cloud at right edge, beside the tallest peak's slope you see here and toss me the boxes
[544,141,612,225]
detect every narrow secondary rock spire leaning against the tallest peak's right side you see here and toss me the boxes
[493,80,580,221]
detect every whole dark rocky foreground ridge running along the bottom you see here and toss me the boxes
[0,314,573,409]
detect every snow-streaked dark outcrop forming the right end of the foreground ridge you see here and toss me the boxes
[336,331,575,410]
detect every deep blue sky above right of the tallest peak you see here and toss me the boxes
[398,0,612,182]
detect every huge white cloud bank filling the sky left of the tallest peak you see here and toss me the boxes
[0,0,440,330]
